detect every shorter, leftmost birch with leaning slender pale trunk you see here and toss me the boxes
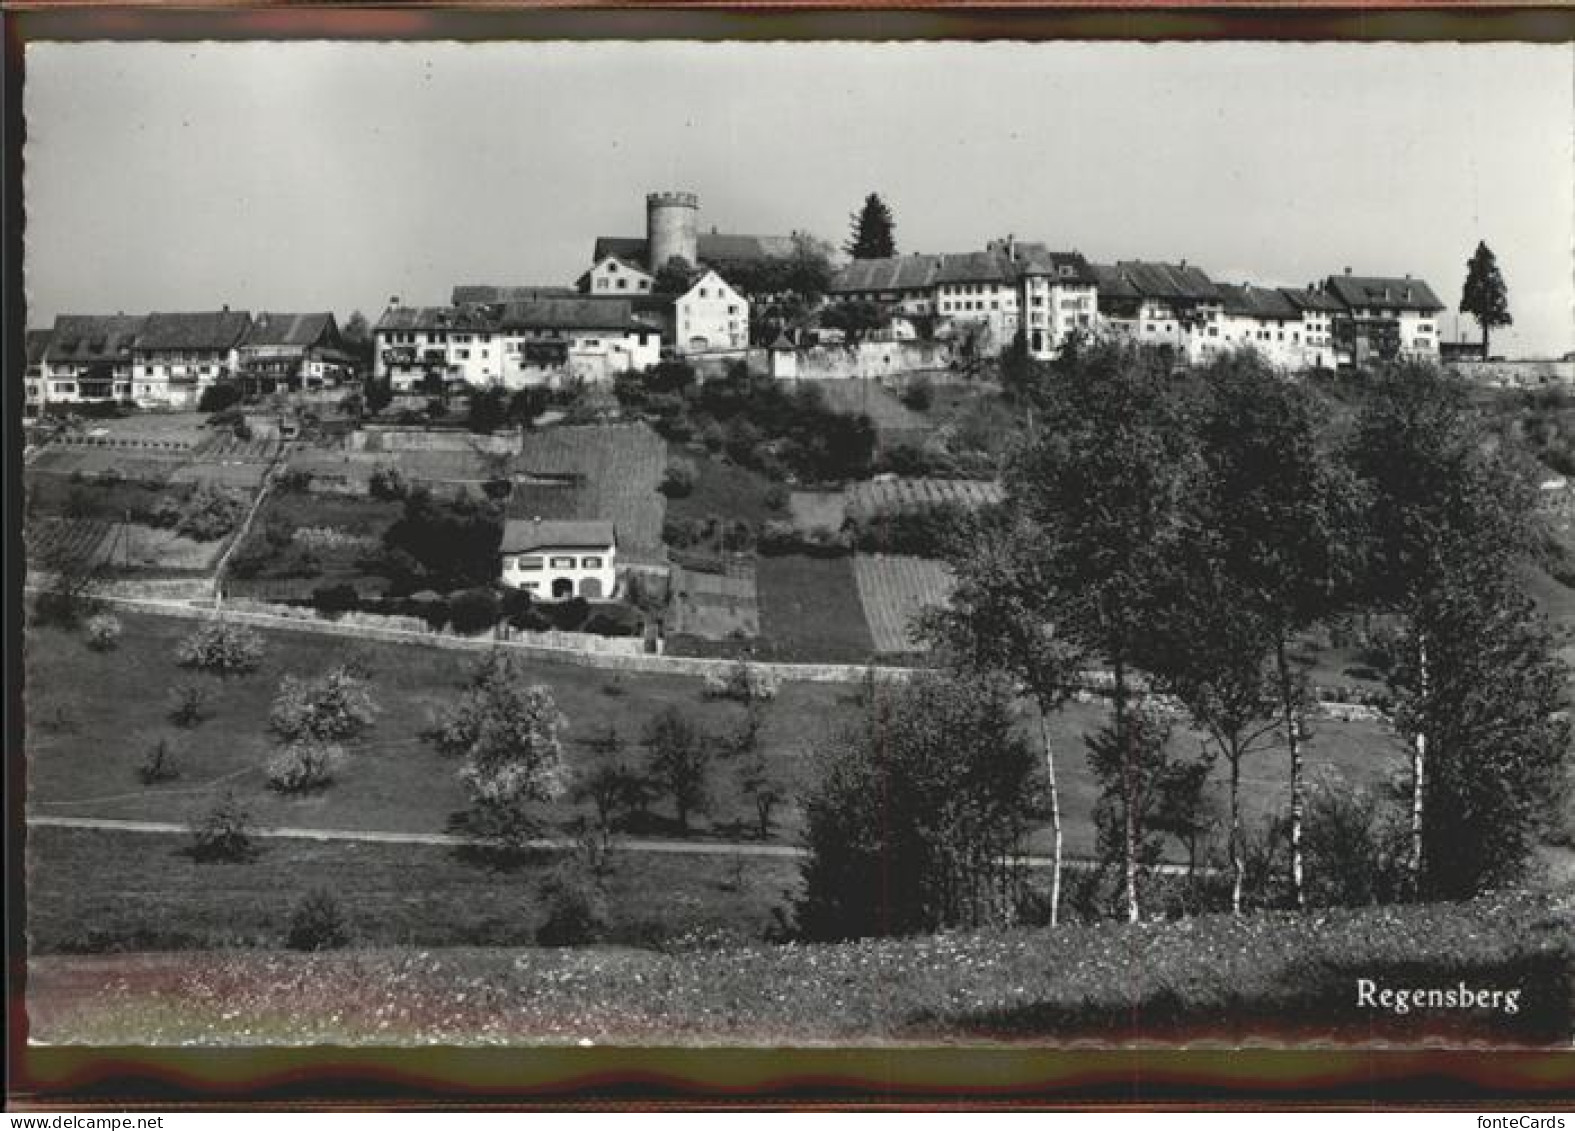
[920,512,1085,926]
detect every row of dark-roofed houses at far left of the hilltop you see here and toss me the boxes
[25,307,356,414]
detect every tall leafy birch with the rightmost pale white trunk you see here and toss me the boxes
[1350,365,1537,893]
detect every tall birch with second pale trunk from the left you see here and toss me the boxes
[1005,342,1195,921]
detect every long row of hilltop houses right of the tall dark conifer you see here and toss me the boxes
[830,236,1444,370]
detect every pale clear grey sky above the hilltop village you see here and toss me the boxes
[24,43,1575,356]
